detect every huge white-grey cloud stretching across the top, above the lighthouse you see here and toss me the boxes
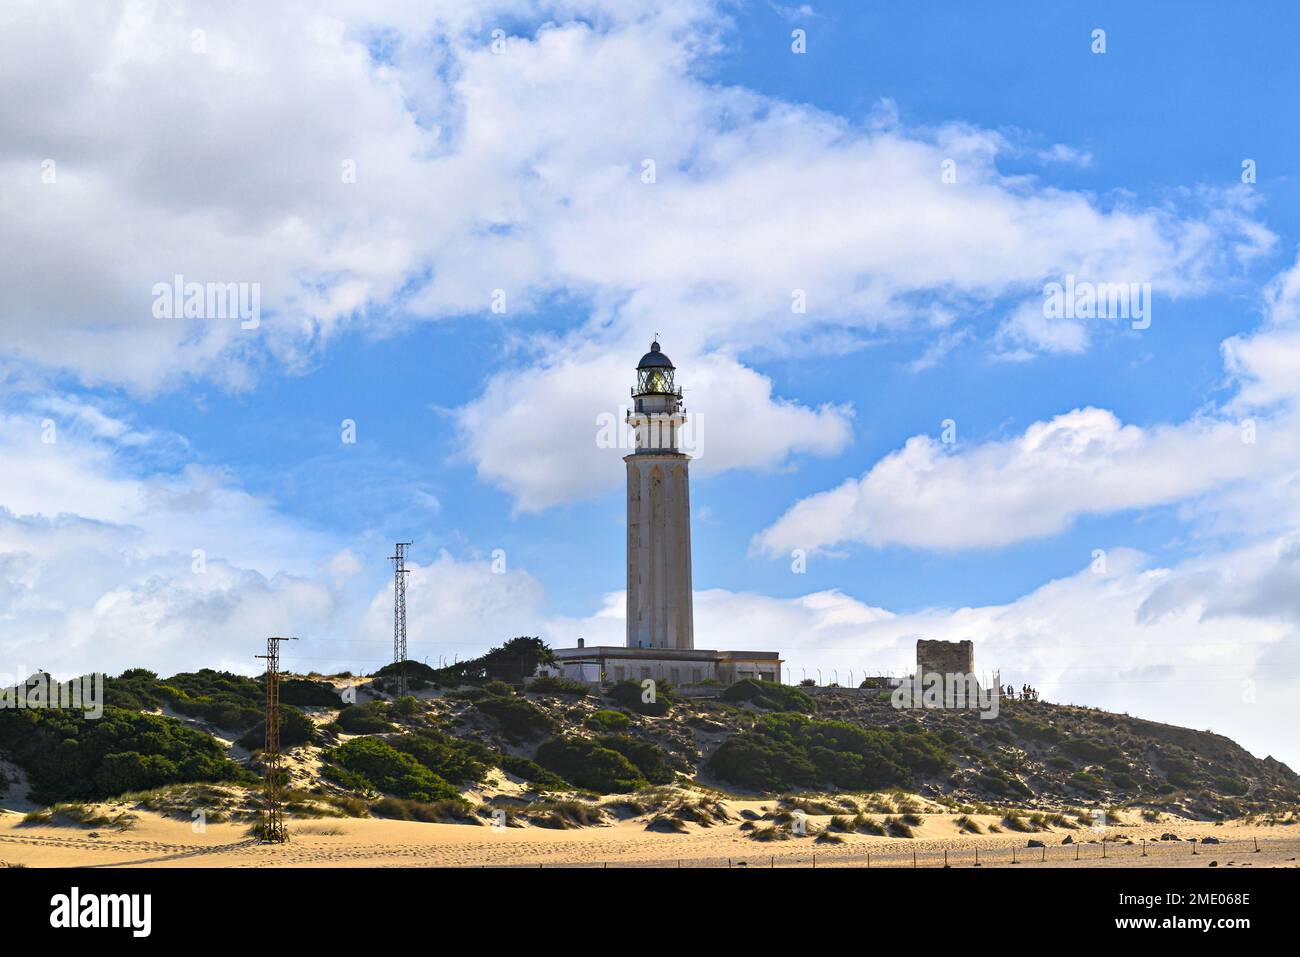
[0,0,1269,400]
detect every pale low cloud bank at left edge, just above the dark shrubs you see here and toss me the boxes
[0,397,355,675]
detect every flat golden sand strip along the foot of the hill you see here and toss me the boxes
[0,802,1300,867]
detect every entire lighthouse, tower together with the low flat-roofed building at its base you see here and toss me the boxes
[555,342,781,684]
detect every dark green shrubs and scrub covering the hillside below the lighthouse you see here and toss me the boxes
[0,655,1300,830]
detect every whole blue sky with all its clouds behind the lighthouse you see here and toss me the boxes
[0,0,1300,761]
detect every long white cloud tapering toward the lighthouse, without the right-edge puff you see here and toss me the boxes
[755,408,1296,554]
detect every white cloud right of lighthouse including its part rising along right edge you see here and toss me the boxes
[754,250,1300,555]
